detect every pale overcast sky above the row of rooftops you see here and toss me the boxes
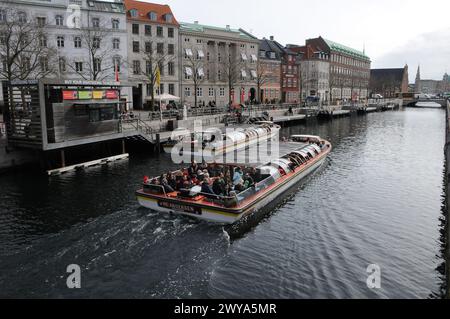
[145,0,450,81]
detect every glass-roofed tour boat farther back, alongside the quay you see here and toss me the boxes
[163,122,281,160]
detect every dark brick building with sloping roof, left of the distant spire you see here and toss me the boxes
[370,65,409,98]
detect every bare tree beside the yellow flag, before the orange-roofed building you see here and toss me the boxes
[138,42,175,111]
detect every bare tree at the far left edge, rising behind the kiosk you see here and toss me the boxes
[0,3,56,112]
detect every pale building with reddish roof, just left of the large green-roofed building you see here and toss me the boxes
[289,45,330,103]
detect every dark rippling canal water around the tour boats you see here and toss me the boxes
[0,109,445,298]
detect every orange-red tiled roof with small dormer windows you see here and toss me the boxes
[124,0,179,26]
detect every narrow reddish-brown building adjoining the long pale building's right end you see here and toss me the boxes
[258,38,283,104]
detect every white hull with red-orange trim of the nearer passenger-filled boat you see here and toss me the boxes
[137,156,327,224]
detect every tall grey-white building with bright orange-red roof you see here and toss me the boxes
[125,0,180,109]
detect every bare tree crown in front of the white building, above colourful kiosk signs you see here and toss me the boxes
[68,26,118,81]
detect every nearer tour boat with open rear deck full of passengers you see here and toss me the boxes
[136,135,332,224]
